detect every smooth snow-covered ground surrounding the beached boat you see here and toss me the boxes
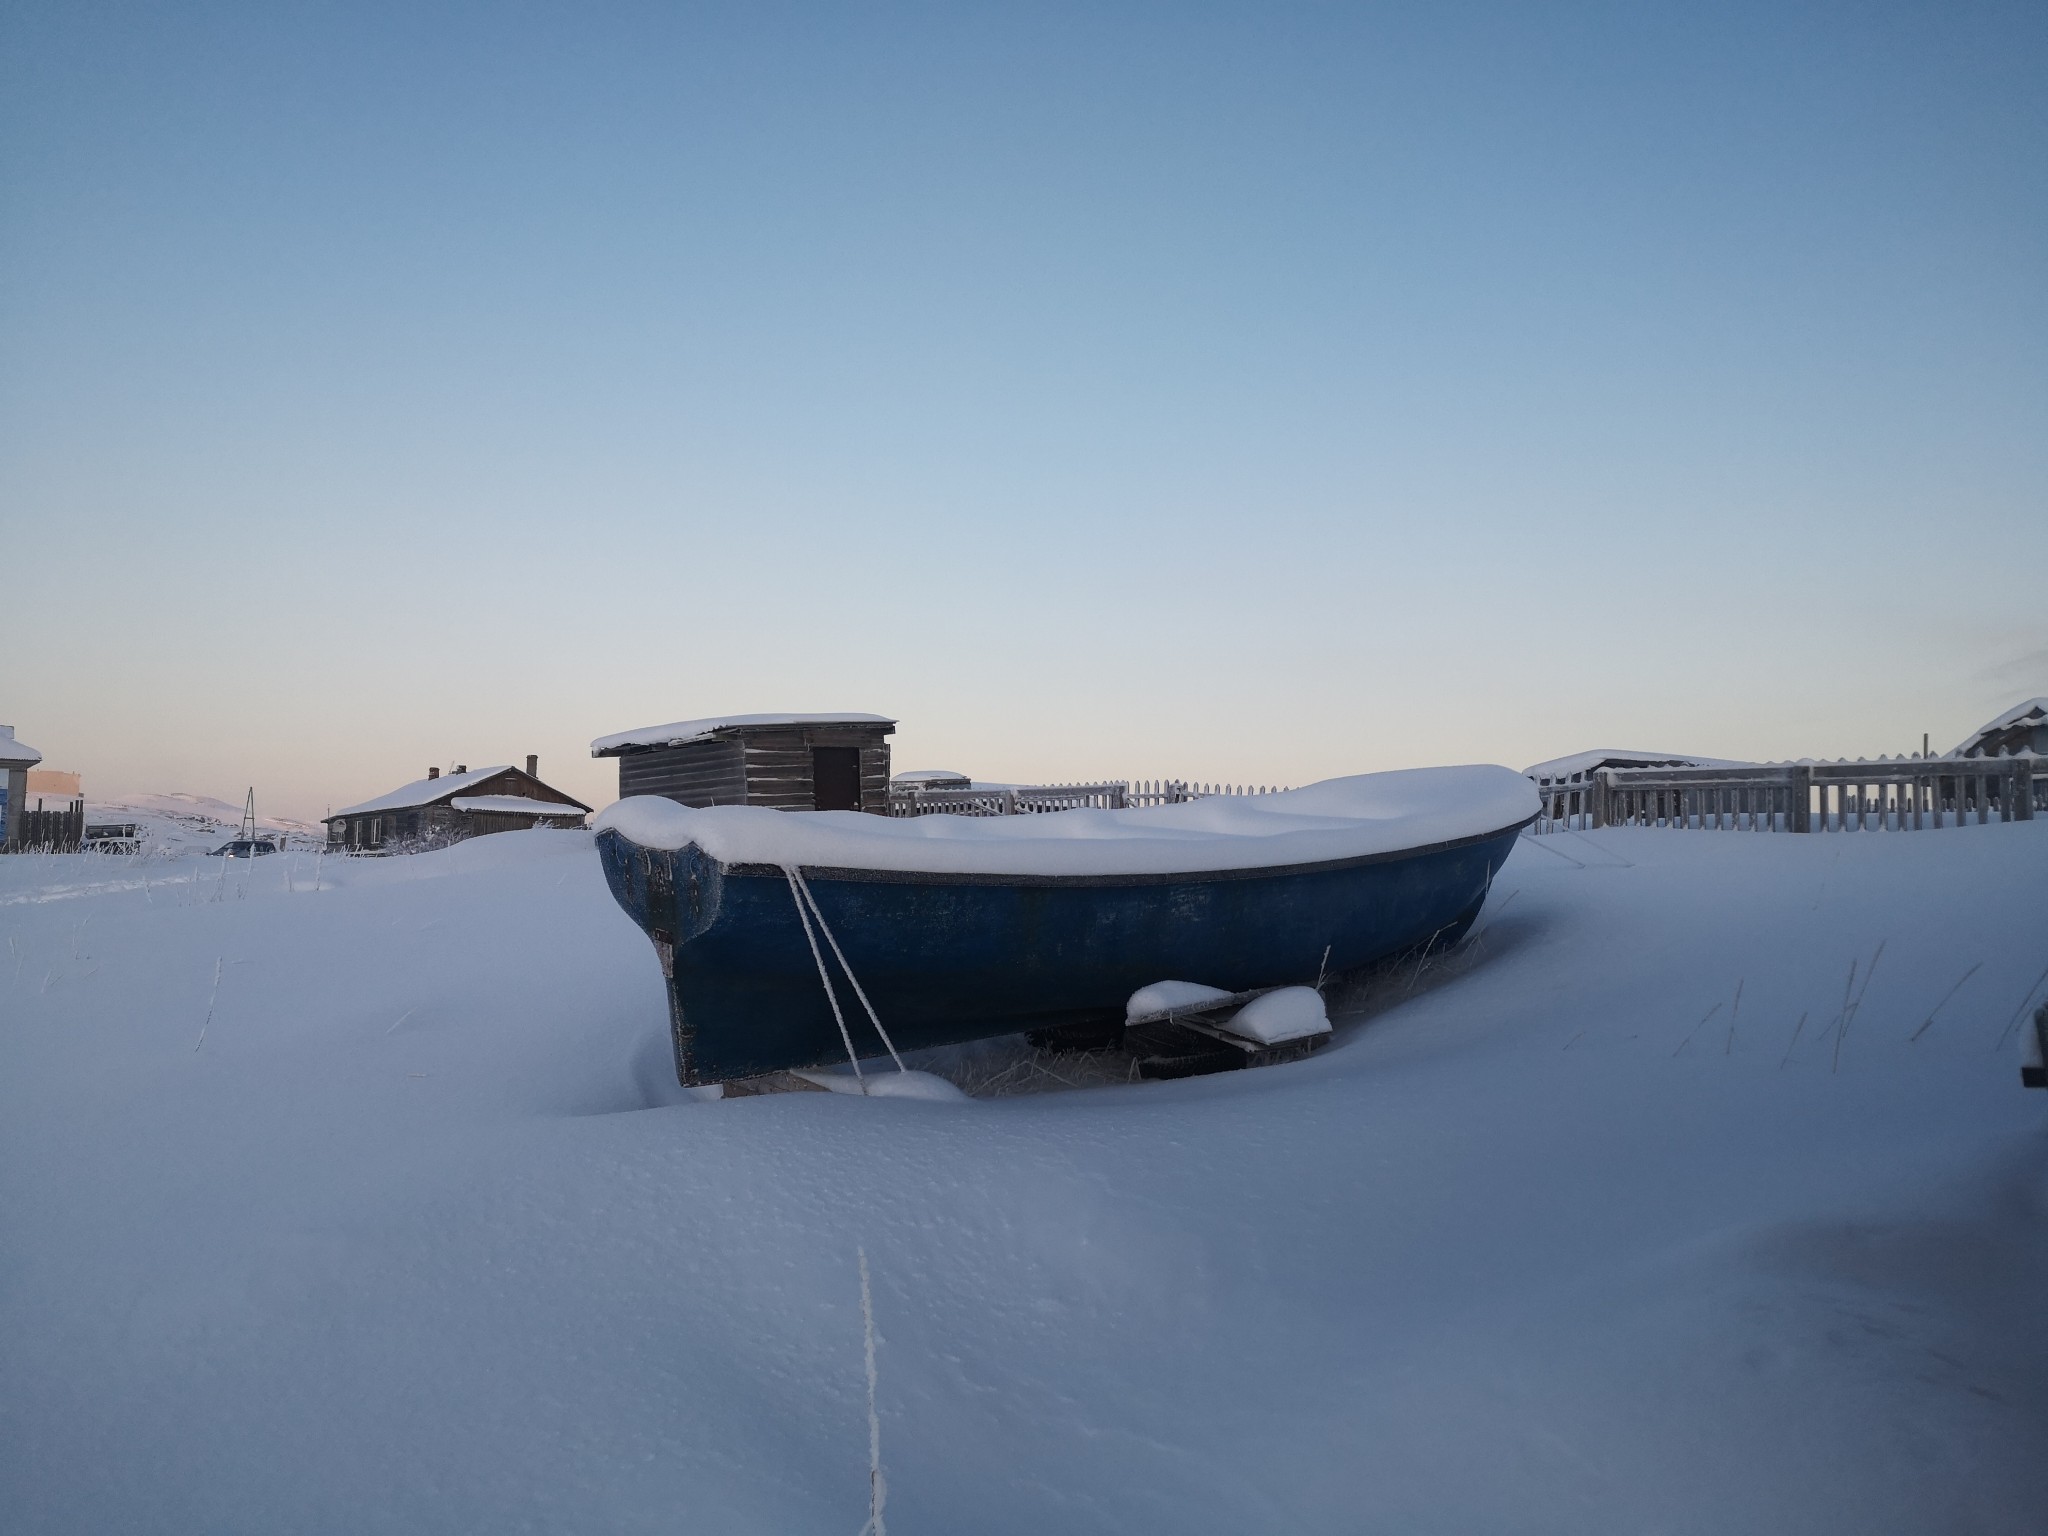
[0,823,2048,1536]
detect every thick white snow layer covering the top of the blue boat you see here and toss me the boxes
[596,764,1540,874]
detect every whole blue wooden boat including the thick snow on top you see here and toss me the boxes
[598,768,1536,1085]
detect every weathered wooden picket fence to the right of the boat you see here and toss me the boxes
[1530,756,2048,834]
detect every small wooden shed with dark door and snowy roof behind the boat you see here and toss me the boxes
[590,715,895,815]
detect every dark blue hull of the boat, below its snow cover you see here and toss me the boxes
[598,813,1522,1083]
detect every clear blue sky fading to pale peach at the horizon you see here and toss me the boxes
[0,2,2048,813]
